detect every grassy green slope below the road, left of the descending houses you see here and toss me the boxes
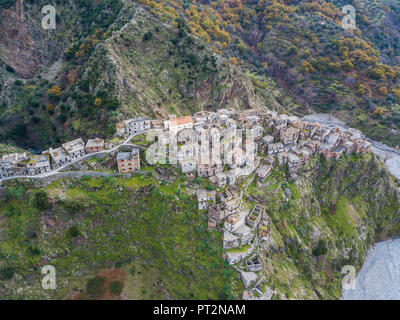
[0,177,234,299]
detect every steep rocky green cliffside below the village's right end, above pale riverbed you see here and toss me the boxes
[244,154,400,299]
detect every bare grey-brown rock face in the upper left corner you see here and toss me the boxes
[0,0,61,78]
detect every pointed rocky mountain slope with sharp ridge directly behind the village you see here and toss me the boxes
[0,1,283,149]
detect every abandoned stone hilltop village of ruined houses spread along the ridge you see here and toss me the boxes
[0,109,371,299]
